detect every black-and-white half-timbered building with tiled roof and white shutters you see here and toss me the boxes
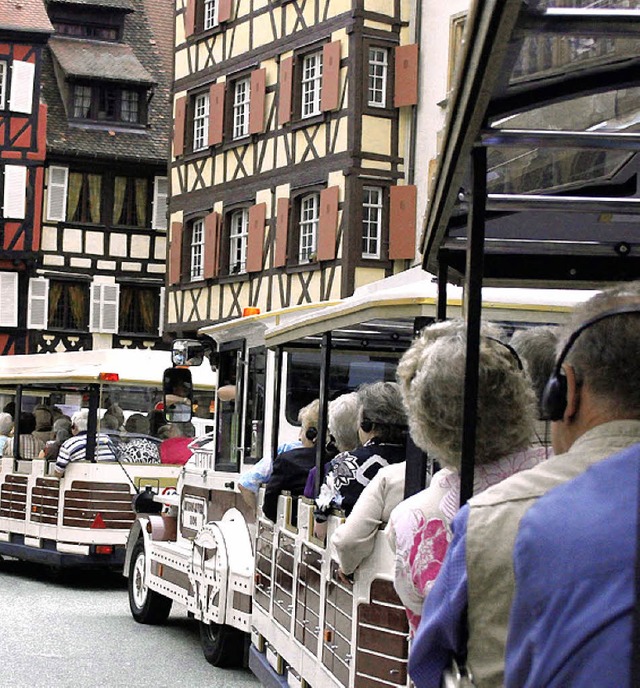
[29,0,173,351]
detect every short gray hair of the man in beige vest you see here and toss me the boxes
[558,280,640,418]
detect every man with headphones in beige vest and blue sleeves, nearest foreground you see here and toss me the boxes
[410,282,640,688]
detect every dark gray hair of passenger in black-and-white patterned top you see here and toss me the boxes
[357,382,407,442]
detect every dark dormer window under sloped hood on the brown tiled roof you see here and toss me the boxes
[72,83,145,124]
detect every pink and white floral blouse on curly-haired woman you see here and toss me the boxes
[387,447,548,635]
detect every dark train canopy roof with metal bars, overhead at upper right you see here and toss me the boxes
[421,0,640,287]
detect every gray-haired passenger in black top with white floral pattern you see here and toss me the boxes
[314,382,407,538]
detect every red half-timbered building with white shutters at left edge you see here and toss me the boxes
[0,0,53,355]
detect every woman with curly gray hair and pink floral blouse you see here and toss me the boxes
[387,320,545,633]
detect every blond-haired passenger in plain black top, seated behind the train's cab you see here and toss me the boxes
[262,399,320,521]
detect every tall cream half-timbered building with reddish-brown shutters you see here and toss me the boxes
[167,0,418,333]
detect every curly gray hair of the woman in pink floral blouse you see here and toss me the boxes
[397,319,536,470]
